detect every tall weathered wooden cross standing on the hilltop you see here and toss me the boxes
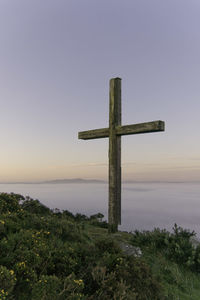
[78,78,165,232]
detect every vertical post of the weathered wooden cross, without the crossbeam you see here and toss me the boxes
[108,78,121,231]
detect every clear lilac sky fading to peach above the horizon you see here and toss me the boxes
[0,0,200,182]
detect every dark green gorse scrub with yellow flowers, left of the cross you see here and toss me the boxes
[0,193,162,300]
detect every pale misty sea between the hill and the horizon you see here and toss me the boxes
[0,182,200,238]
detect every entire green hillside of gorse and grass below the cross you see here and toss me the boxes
[0,193,200,300]
